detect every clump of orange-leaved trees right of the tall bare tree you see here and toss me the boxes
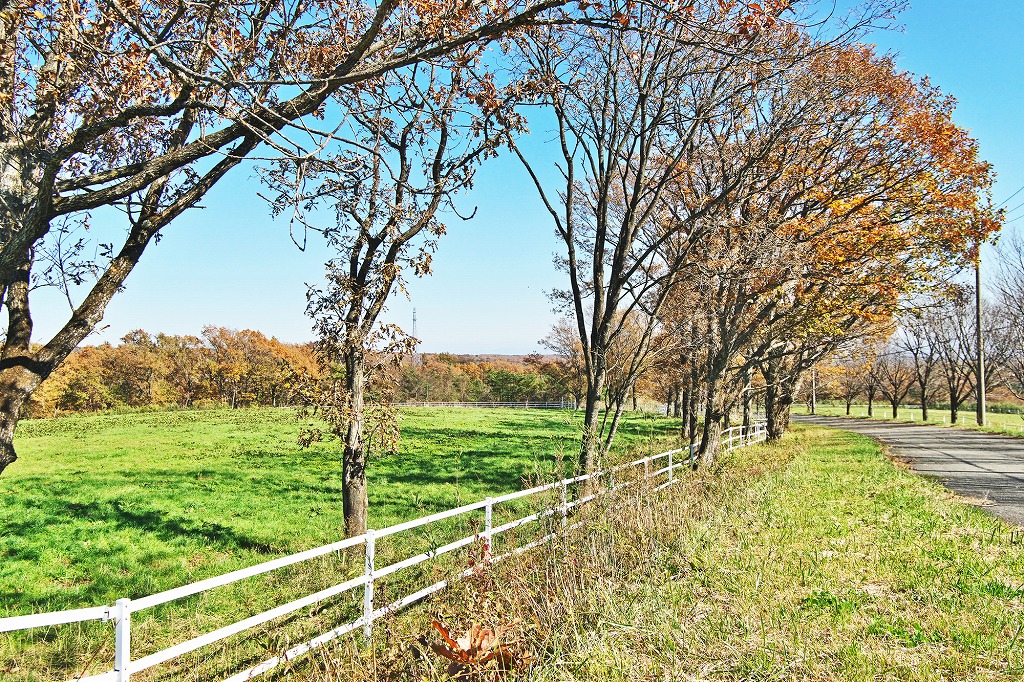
[647,33,999,456]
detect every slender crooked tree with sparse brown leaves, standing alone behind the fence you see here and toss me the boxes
[267,61,520,535]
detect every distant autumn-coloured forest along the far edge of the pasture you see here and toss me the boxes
[27,327,583,418]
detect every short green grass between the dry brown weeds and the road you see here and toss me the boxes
[536,421,1024,680]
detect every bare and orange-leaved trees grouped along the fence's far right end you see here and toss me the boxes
[519,3,999,470]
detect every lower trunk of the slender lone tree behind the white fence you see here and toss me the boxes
[342,348,370,538]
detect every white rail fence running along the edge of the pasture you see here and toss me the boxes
[0,424,767,682]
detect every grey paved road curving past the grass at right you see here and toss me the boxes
[794,409,1024,525]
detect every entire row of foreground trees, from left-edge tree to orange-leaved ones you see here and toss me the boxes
[0,0,999,534]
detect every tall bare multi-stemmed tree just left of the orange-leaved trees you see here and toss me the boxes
[515,0,806,471]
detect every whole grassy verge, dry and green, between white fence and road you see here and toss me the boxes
[319,427,1024,682]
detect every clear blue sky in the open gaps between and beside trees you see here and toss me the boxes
[34,0,1024,353]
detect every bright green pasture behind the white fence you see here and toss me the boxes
[0,409,678,679]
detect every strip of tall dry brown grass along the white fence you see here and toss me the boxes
[276,438,784,682]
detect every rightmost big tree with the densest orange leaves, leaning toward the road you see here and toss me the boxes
[745,47,1001,437]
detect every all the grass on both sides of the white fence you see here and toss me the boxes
[8,410,1024,682]
